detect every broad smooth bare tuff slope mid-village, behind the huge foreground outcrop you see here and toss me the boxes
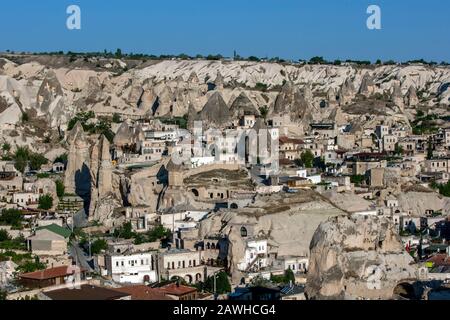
[200,190,343,283]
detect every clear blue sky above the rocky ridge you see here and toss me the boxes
[0,0,450,62]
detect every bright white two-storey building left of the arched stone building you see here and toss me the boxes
[106,252,158,284]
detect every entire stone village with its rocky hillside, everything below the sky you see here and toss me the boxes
[0,53,450,300]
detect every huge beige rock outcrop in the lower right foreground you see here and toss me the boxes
[306,216,416,299]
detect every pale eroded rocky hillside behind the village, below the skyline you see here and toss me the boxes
[0,55,450,158]
